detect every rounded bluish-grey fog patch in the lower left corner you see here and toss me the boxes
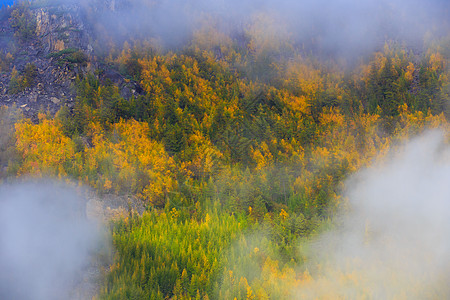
[0,182,99,300]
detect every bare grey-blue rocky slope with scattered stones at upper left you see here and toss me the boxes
[0,1,139,121]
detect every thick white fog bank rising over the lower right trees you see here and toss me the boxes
[294,131,450,299]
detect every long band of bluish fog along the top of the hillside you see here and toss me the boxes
[55,0,449,58]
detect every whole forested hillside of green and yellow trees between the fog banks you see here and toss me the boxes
[0,1,450,299]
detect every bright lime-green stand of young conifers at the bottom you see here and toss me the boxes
[100,209,243,299]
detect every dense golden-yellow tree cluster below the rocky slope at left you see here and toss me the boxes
[15,116,179,205]
